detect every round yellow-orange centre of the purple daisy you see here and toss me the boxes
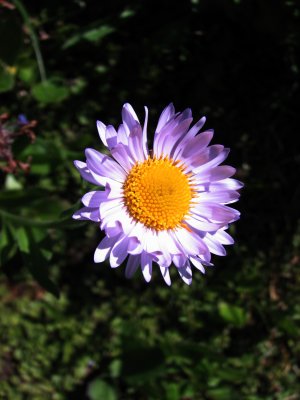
[123,157,193,231]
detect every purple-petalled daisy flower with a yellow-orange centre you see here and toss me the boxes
[73,104,242,285]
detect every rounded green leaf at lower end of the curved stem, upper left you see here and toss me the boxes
[32,80,69,104]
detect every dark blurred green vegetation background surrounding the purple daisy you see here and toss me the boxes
[0,0,300,400]
